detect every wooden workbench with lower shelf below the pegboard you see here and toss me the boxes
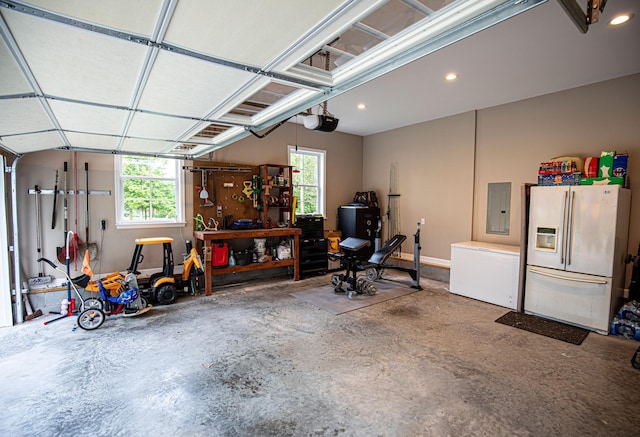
[193,228,302,296]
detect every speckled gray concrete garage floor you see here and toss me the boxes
[0,276,640,436]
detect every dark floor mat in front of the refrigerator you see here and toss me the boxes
[496,311,589,345]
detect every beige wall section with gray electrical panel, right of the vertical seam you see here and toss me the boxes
[473,75,640,249]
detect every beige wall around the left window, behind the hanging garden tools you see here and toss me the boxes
[17,151,193,279]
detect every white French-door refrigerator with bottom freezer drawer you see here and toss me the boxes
[524,185,631,335]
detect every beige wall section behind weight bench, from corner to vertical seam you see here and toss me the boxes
[363,112,475,264]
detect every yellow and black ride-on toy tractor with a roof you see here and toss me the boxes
[127,237,204,305]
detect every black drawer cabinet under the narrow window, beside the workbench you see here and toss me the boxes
[295,216,329,277]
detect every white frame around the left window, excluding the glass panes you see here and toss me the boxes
[113,155,186,229]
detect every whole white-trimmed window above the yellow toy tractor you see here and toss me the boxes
[114,155,185,228]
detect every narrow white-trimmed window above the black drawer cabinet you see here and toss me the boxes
[289,146,327,216]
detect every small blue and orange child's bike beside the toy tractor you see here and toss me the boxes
[78,272,152,331]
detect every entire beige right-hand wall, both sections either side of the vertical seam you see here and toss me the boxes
[363,74,640,260]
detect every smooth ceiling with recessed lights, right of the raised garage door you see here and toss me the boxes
[328,0,640,135]
